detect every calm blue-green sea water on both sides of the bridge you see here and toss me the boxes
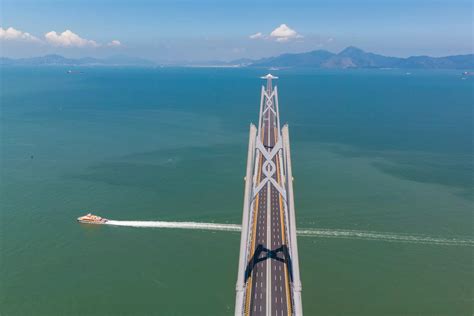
[0,67,474,315]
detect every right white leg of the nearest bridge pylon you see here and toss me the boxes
[281,125,303,316]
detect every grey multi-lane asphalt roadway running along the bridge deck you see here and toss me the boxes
[247,89,291,316]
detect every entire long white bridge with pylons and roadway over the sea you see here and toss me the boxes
[235,74,303,316]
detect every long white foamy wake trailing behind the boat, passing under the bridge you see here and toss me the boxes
[105,220,474,246]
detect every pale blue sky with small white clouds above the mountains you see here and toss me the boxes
[0,0,474,62]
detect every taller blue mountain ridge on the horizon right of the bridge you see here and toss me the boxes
[249,46,474,69]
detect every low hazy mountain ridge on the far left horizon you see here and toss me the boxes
[0,54,155,66]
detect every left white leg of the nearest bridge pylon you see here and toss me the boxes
[235,124,257,316]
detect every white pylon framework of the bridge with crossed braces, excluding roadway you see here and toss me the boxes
[235,74,303,315]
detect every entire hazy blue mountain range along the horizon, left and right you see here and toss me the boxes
[0,46,474,69]
